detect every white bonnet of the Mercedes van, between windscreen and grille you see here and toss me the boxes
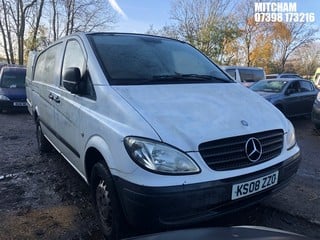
[114,83,287,151]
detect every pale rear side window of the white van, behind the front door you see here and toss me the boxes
[34,43,62,84]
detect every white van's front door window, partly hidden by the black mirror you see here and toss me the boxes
[60,40,95,99]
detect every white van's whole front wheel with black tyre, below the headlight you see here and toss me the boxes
[91,162,128,240]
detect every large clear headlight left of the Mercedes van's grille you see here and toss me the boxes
[124,137,200,175]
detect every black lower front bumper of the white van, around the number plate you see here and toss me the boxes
[115,152,301,228]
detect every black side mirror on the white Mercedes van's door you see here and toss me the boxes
[62,67,81,94]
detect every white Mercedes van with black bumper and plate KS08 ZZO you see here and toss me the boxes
[27,33,300,239]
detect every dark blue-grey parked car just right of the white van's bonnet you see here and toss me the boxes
[250,78,318,117]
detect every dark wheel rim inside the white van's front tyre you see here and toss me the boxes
[96,180,112,233]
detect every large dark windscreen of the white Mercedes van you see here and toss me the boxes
[88,34,233,85]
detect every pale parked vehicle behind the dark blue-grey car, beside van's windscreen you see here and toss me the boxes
[221,66,265,87]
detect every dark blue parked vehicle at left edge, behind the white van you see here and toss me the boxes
[0,66,27,112]
